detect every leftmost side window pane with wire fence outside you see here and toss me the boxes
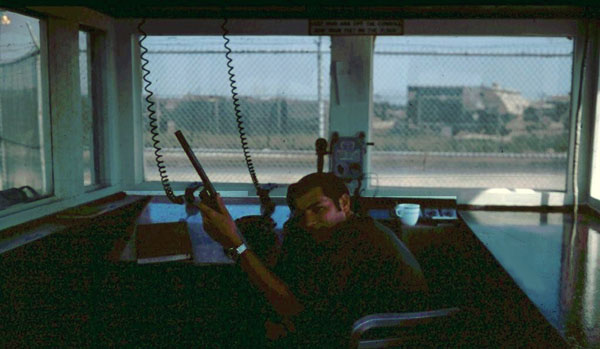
[0,8,52,210]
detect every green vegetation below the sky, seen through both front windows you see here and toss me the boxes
[145,97,569,153]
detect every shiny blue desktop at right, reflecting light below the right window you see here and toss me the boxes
[459,210,600,347]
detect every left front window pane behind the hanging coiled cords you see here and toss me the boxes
[142,36,330,183]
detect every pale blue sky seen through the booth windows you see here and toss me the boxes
[0,8,573,104]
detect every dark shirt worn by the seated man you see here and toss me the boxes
[274,215,427,346]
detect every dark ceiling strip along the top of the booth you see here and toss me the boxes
[2,0,600,19]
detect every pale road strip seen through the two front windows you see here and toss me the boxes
[144,149,567,191]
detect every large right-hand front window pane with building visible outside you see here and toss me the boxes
[371,36,573,191]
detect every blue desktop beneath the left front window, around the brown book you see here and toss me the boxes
[120,196,290,265]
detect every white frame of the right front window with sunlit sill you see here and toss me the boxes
[365,19,587,206]
